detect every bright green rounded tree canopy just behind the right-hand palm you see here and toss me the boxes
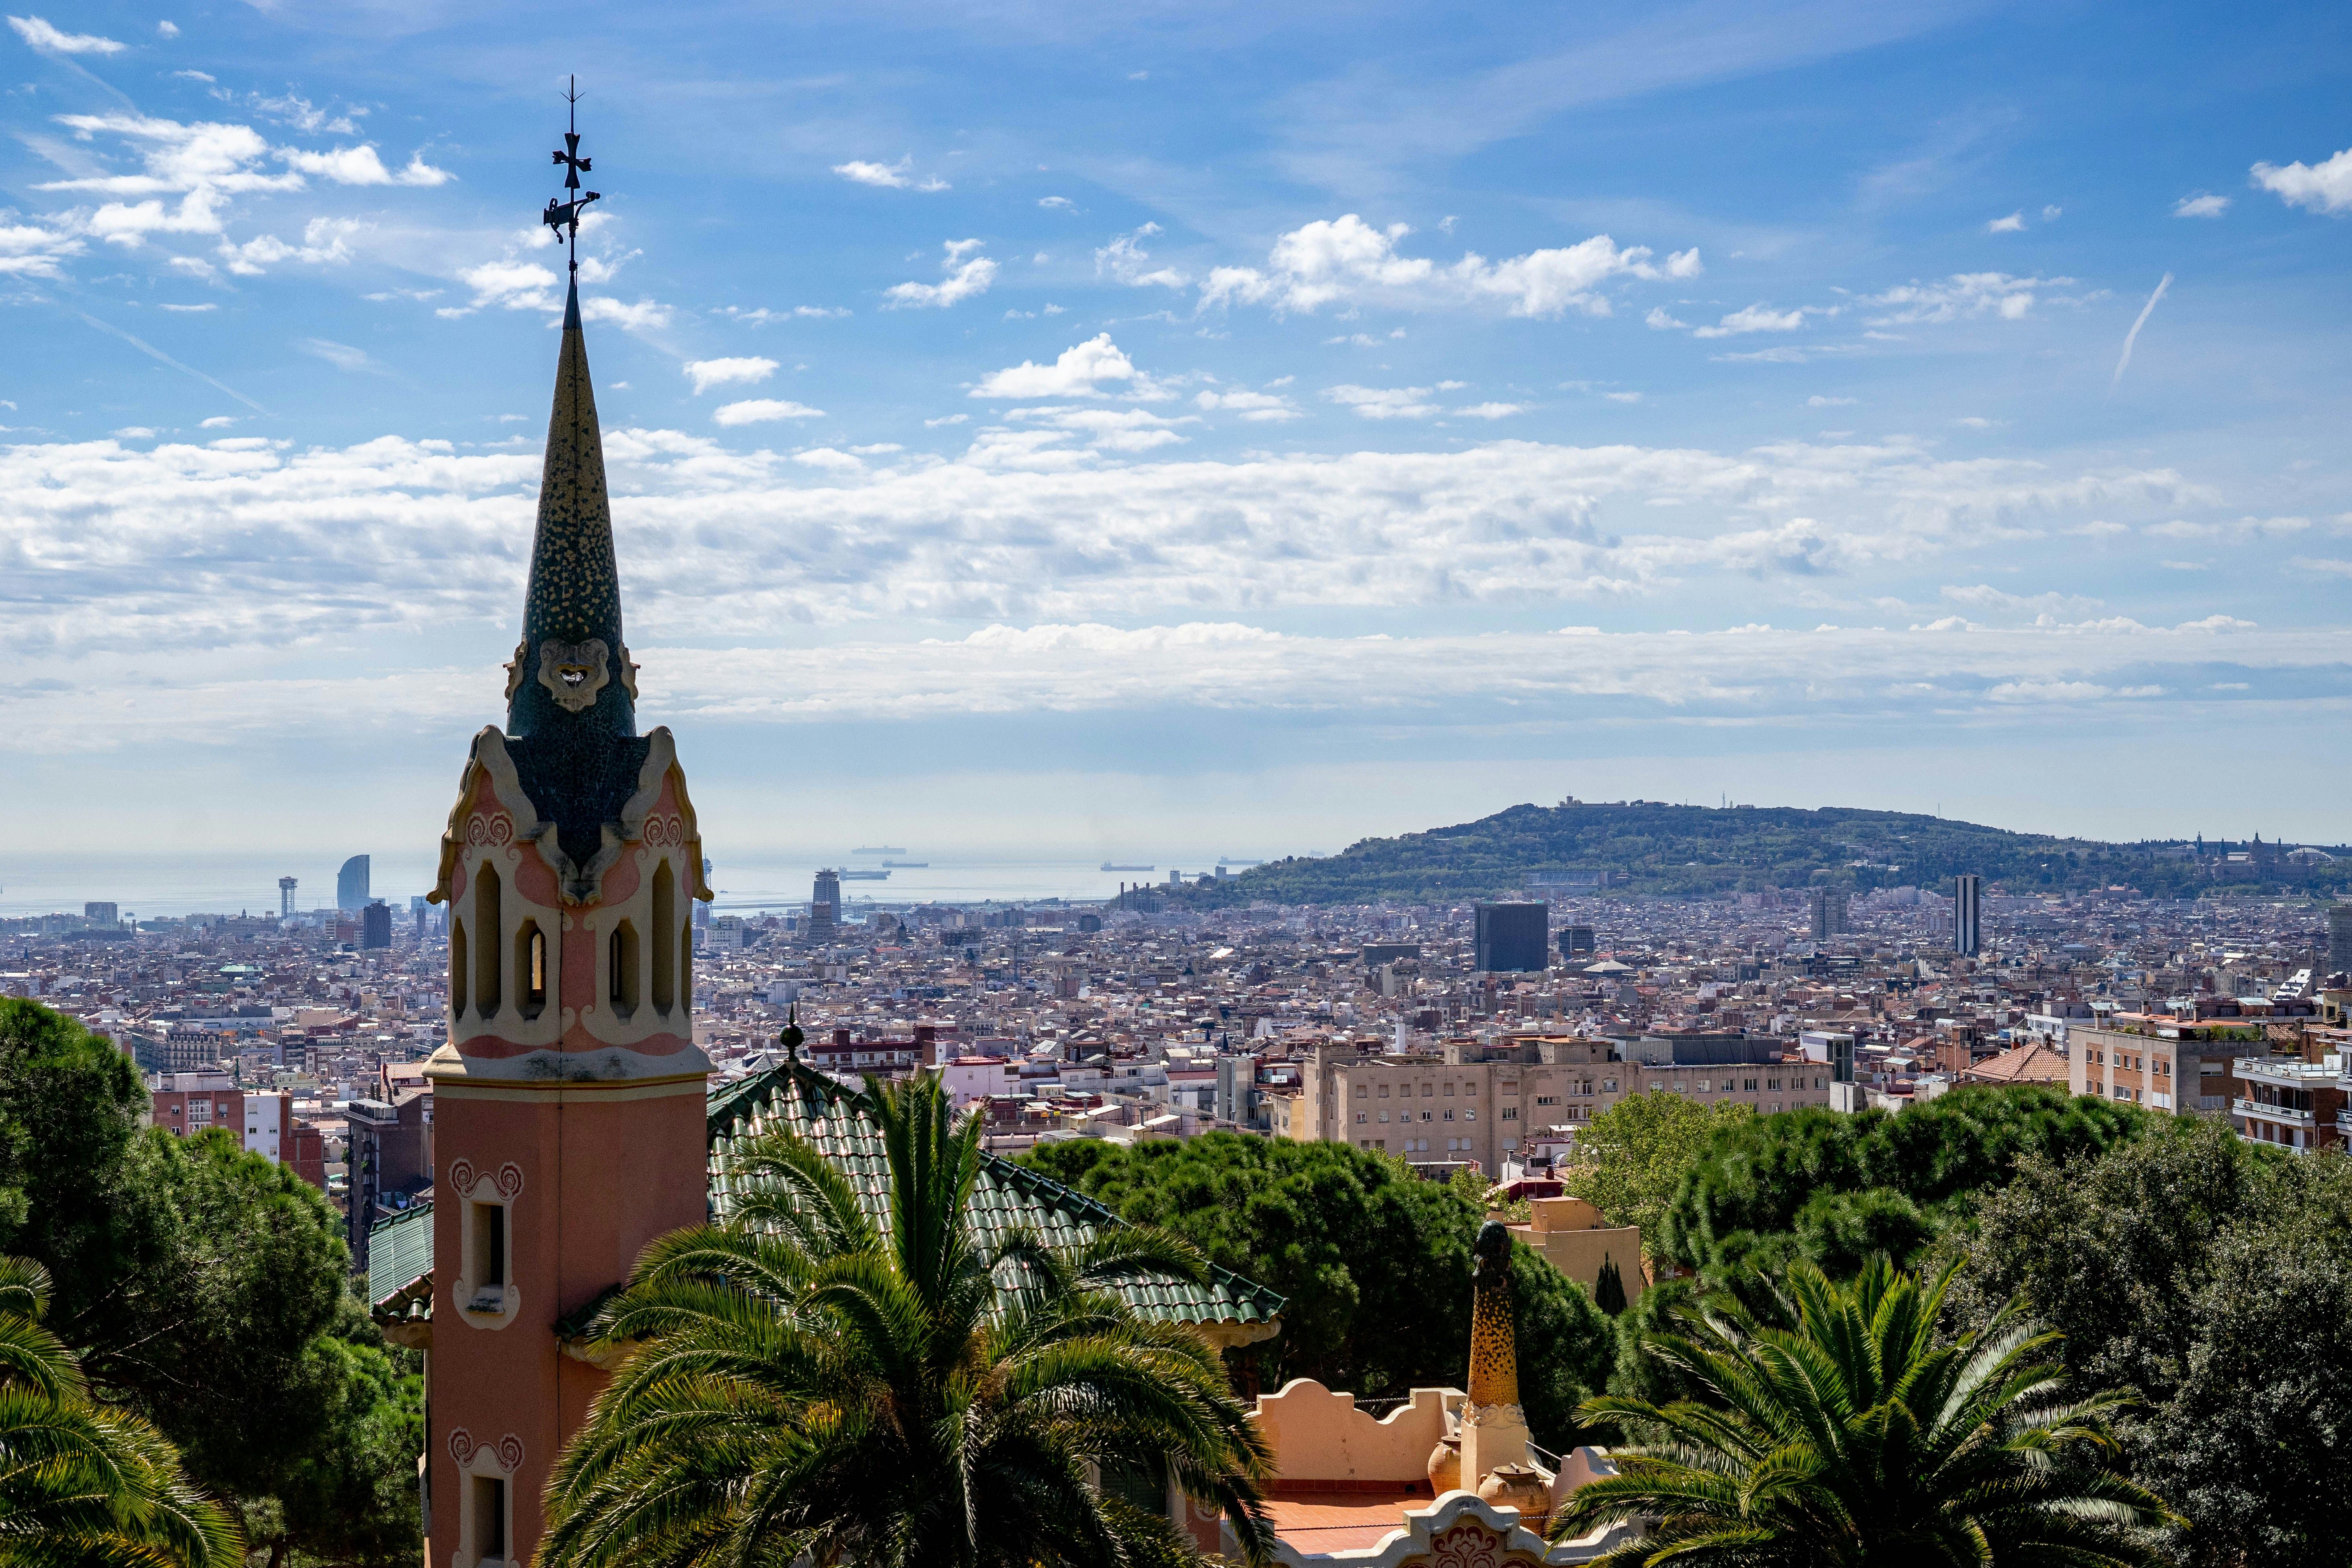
[1656,1086,2148,1281]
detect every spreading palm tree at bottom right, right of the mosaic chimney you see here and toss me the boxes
[1550,1255,2183,1568]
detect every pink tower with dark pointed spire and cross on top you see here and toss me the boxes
[426,101,710,1568]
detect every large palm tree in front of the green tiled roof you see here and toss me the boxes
[541,1084,1273,1568]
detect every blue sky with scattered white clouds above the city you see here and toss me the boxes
[0,0,2352,888]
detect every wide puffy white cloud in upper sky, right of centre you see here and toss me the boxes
[1199,212,1703,318]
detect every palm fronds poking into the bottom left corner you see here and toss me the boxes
[0,1258,245,1568]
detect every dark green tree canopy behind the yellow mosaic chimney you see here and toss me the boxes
[1025,1133,1616,1448]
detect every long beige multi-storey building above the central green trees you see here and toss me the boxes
[1273,1037,1830,1171]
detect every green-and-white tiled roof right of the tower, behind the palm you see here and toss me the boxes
[710,1065,1282,1324]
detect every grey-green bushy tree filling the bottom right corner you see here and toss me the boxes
[1954,1119,2352,1568]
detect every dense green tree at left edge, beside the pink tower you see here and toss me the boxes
[0,1001,423,1563]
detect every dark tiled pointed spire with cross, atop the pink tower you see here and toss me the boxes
[505,92,638,736]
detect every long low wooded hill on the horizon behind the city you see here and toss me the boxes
[1181,799,2352,908]
